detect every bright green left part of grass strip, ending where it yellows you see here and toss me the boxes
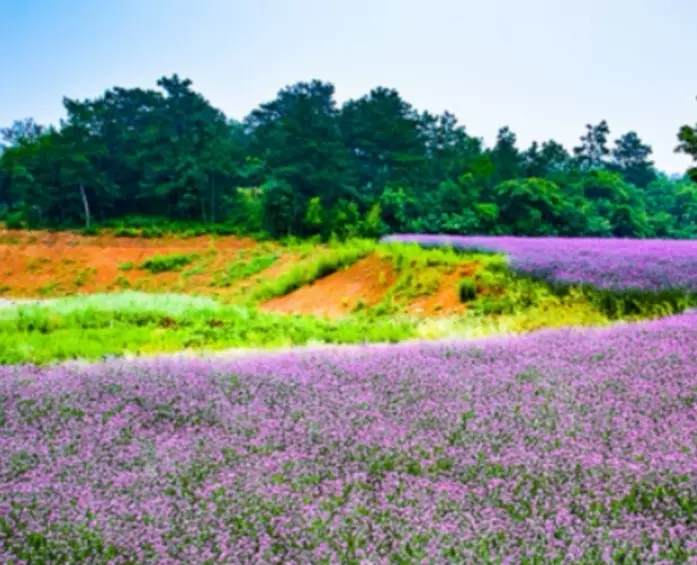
[0,292,416,364]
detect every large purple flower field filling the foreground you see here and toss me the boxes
[0,314,697,564]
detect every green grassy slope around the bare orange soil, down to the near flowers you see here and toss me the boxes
[0,231,690,364]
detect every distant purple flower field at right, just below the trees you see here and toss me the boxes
[383,234,697,291]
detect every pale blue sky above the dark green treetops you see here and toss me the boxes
[0,0,697,173]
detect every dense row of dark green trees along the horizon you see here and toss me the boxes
[0,75,697,238]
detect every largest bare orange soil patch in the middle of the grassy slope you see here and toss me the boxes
[262,255,397,318]
